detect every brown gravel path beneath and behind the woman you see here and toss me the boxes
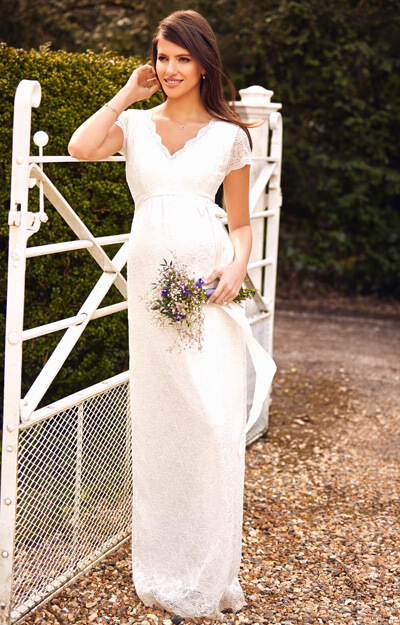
[26,308,400,625]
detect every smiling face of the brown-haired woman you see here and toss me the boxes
[156,37,203,98]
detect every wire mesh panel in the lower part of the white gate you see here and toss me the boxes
[12,382,132,619]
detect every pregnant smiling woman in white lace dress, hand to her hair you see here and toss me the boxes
[69,11,251,618]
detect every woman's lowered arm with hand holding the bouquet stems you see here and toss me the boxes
[206,165,252,304]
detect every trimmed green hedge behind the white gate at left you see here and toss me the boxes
[0,45,159,412]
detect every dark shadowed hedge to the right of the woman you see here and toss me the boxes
[211,0,400,298]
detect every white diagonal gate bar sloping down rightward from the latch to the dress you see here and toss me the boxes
[30,164,127,299]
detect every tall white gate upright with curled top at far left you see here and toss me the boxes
[0,80,41,625]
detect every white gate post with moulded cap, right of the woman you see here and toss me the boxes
[235,85,282,443]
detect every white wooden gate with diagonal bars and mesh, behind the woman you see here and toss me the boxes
[0,80,282,624]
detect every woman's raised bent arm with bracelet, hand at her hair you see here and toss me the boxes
[68,65,160,160]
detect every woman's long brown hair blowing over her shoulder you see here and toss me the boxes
[152,10,254,147]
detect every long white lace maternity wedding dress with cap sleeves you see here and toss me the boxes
[118,109,251,618]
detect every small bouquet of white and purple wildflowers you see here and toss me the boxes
[146,258,255,350]
